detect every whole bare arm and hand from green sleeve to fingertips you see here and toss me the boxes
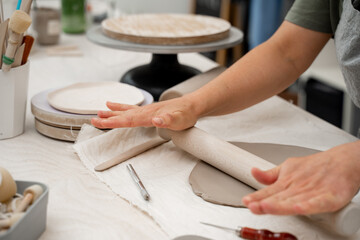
[92,22,330,130]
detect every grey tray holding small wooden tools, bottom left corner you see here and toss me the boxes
[0,181,49,240]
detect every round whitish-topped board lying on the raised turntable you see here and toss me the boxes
[101,14,231,45]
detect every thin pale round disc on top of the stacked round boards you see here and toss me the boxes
[48,81,144,114]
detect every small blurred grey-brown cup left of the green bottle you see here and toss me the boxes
[33,7,61,45]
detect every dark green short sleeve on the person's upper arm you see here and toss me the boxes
[285,0,333,33]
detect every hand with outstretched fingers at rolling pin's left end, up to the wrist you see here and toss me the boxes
[91,97,199,130]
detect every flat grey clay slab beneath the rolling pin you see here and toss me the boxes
[189,142,319,207]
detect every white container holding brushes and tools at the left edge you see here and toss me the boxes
[0,61,30,139]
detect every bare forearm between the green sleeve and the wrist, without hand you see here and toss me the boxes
[187,23,329,117]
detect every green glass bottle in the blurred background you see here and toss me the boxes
[61,0,86,33]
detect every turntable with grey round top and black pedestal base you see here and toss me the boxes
[87,23,243,101]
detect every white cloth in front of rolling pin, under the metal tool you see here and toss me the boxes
[74,125,319,239]
